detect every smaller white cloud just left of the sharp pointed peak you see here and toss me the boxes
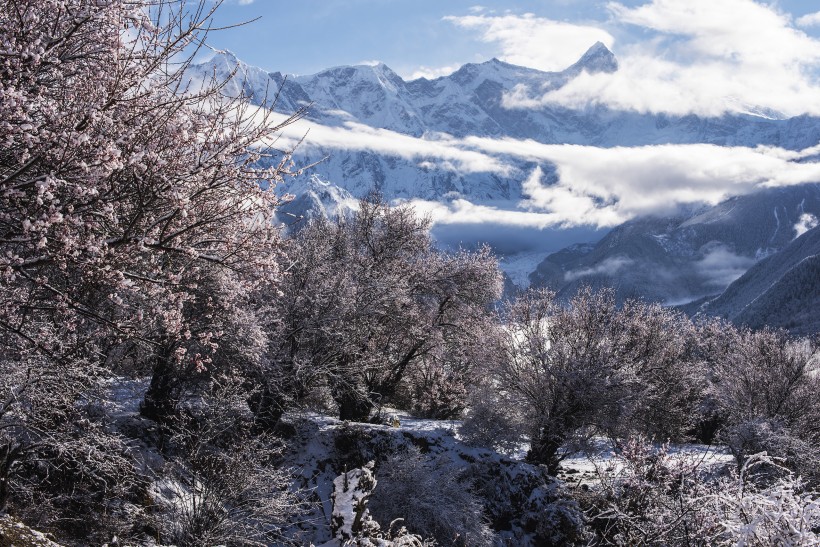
[444,13,615,71]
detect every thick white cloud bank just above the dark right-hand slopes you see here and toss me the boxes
[465,137,820,227]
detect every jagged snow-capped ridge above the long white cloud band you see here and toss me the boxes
[191,43,820,150]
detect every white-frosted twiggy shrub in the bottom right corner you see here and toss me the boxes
[582,439,820,547]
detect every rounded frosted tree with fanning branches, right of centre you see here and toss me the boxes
[466,289,700,474]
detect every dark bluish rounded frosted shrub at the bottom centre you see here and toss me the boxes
[370,446,495,547]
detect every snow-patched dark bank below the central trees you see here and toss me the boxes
[286,410,733,545]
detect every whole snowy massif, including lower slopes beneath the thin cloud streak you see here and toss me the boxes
[190,43,820,208]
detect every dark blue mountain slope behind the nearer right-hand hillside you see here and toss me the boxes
[530,184,820,304]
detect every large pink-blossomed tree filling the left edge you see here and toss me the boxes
[0,0,302,372]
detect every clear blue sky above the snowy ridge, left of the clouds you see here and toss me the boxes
[210,0,820,77]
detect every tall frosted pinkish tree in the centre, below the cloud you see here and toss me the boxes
[273,199,500,421]
